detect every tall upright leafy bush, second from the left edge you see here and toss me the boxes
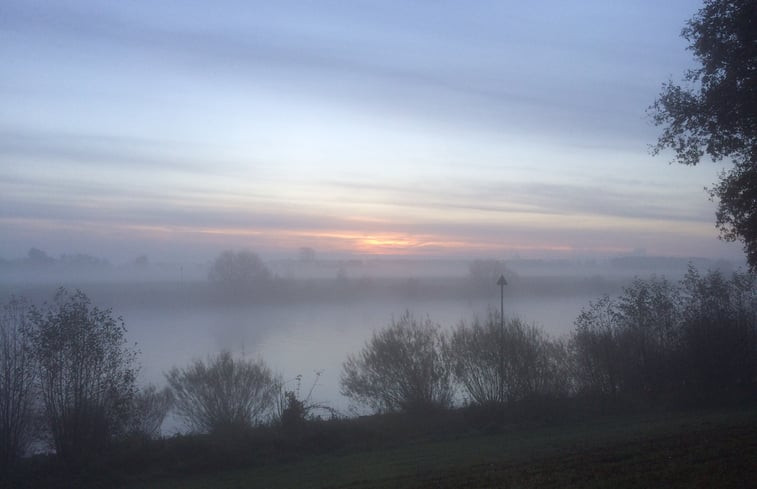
[29,288,136,463]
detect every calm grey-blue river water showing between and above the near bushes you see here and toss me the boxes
[121,295,592,416]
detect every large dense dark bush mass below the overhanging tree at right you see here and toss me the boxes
[571,268,757,402]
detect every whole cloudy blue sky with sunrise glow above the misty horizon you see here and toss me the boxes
[0,0,742,262]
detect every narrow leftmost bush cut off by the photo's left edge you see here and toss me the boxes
[0,298,36,471]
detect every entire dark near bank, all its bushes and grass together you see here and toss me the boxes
[0,268,757,488]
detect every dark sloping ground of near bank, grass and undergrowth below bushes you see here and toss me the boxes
[11,404,757,489]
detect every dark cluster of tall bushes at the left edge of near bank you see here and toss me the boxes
[0,288,170,487]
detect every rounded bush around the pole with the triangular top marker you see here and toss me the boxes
[448,312,570,405]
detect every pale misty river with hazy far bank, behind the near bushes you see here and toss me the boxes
[0,254,740,433]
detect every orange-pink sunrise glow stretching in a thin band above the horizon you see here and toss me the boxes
[0,218,716,258]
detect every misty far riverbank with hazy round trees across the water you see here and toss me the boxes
[0,251,629,307]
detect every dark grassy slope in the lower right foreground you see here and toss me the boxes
[132,408,757,489]
